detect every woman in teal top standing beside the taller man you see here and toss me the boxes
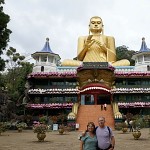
[80,122,97,150]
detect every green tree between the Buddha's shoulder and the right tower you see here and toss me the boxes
[116,45,135,66]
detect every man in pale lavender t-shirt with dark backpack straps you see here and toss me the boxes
[96,117,115,150]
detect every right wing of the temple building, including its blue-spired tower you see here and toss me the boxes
[112,38,150,115]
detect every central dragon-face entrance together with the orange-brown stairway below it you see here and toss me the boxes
[77,62,115,130]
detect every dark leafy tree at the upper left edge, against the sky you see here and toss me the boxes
[0,0,11,71]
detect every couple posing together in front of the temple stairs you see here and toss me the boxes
[80,117,115,150]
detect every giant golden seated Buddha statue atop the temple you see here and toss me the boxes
[61,16,130,66]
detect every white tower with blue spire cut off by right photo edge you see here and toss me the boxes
[132,37,150,71]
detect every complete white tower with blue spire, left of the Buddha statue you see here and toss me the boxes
[31,38,60,72]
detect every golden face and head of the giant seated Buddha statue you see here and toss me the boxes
[89,17,103,33]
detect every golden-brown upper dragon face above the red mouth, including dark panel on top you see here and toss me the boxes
[77,62,114,89]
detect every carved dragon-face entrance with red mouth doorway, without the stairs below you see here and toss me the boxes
[77,62,115,105]
